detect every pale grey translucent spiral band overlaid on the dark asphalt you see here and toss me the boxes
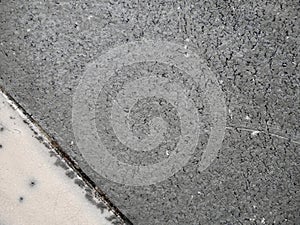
[72,40,226,186]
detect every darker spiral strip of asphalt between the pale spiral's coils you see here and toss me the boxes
[96,62,197,166]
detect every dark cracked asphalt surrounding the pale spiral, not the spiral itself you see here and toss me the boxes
[0,0,300,225]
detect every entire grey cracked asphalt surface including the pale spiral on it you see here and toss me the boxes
[0,0,300,225]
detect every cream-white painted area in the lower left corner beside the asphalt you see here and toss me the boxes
[0,92,121,225]
